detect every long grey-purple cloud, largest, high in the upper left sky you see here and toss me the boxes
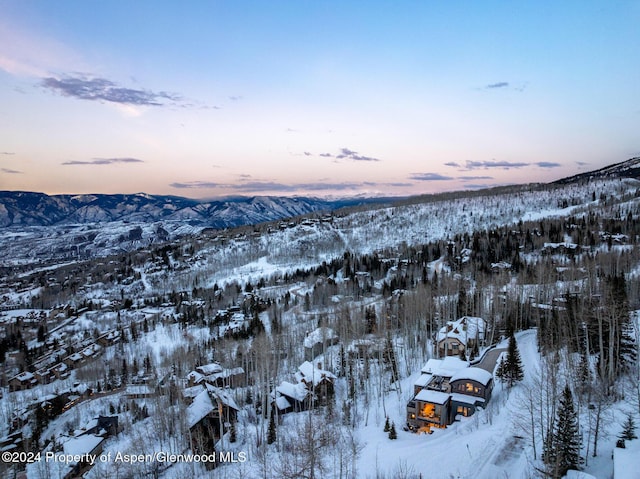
[40,76,184,106]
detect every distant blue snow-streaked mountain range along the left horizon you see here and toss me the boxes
[0,191,382,228]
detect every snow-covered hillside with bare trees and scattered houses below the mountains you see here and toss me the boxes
[0,167,640,479]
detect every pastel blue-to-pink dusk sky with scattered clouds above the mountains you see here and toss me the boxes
[0,0,640,198]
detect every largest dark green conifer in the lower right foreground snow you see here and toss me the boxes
[543,384,580,479]
